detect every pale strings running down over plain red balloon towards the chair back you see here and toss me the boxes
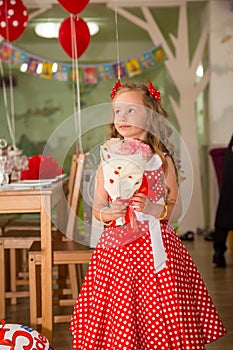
[71,16,83,153]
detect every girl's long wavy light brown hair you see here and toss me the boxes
[109,82,180,182]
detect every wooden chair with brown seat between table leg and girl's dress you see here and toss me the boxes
[28,154,94,328]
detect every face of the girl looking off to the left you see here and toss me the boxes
[113,91,148,141]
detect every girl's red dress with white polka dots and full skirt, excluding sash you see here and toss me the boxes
[70,157,226,350]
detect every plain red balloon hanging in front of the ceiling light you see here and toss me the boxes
[58,16,91,58]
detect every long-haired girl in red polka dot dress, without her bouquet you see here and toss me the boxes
[70,81,226,350]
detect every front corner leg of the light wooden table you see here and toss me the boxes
[41,195,53,341]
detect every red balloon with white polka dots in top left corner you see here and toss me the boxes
[0,0,28,41]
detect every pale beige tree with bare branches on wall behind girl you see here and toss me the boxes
[108,2,210,230]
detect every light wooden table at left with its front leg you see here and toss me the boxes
[0,179,67,341]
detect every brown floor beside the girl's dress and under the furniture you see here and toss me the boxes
[3,235,233,350]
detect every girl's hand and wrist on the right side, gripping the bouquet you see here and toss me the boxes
[130,192,163,217]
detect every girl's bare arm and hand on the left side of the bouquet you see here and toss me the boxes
[93,166,127,224]
